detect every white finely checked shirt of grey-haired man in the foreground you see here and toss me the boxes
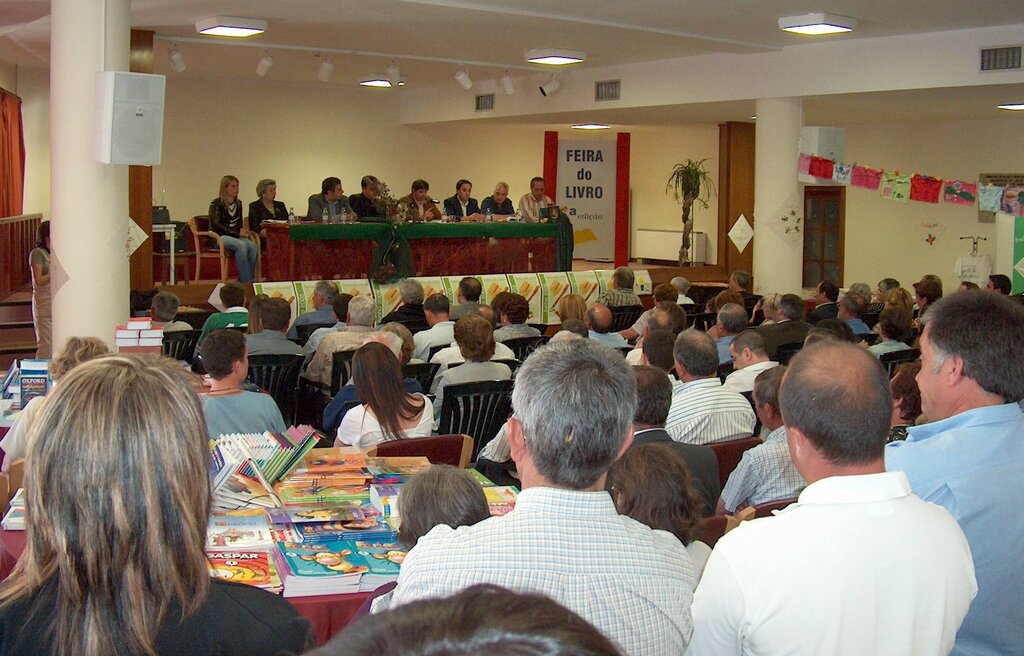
[391,487,693,656]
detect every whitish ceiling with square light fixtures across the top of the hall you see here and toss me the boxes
[0,0,1024,125]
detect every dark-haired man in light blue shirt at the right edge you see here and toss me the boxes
[886,291,1024,656]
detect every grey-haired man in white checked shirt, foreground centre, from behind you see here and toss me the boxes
[391,340,693,656]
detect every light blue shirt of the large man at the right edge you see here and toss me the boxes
[886,403,1024,656]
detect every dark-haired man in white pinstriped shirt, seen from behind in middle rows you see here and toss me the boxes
[665,329,757,444]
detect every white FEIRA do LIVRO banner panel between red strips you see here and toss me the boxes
[556,140,615,262]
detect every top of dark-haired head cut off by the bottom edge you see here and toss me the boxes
[307,585,622,656]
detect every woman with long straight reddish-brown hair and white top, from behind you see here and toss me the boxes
[335,342,434,450]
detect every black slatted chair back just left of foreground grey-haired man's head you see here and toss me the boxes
[437,381,512,460]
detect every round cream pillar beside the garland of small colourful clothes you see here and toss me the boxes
[753,98,804,294]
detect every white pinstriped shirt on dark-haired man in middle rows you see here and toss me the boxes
[665,376,757,444]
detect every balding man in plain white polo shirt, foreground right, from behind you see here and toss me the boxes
[687,341,978,656]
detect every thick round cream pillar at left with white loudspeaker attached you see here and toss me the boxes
[50,0,131,351]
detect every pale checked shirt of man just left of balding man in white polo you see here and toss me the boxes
[722,426,807,513]
